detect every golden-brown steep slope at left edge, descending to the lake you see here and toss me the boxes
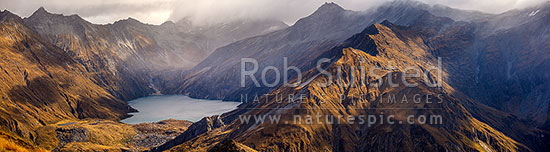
[0,11,135,140]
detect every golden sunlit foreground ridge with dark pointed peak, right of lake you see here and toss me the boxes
[163,22,548,151]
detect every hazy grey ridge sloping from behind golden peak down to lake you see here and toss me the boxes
[163,3,470,101]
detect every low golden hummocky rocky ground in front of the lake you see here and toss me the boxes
[35,119,191,151]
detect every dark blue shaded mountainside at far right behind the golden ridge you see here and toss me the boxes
[430,3,550,126]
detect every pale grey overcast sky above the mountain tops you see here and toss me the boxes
[0,0,548,24]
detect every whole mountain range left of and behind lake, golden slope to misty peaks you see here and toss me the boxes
[0,8,286,151]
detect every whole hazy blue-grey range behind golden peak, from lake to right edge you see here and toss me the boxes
[162,1,550,129]
